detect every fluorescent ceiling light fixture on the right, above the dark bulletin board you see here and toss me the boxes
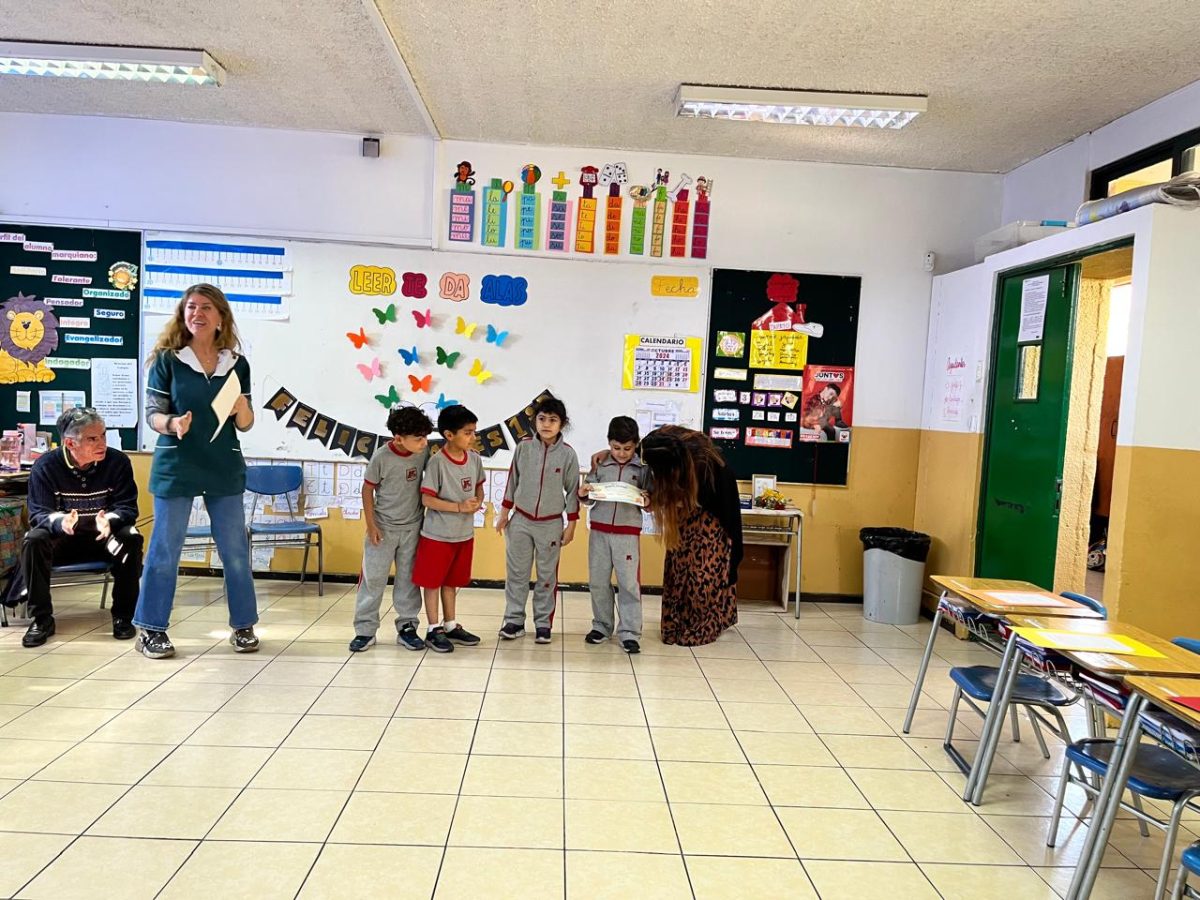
[676,84,928,128]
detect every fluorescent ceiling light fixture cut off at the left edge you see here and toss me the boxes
[0,41,224,86]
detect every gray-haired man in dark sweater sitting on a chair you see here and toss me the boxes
[13,407,142,647]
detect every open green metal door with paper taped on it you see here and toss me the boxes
[978,265,1079,588]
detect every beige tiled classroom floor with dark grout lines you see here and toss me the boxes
[0,578,1200,900]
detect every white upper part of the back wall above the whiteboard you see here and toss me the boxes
[0,114,1001,428]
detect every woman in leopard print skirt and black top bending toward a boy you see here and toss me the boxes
[642,425,742,647]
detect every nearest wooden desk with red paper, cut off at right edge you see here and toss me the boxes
[1067,672,1200,900]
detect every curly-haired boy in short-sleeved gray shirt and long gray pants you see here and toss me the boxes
[350,407,433,653]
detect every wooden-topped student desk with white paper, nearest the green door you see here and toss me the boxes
[904,575,1103,734]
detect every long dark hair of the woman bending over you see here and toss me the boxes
[642,425,725,550]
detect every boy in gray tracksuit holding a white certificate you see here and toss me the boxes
[580,415,647,653]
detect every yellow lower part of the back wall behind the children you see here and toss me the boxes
[131,426,920,602]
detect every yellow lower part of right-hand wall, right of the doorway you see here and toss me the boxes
[1104,445,1200,637]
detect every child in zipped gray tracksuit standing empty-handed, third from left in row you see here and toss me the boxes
[496,397,580,643]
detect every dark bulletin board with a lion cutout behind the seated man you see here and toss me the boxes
[0,223,142,450]
